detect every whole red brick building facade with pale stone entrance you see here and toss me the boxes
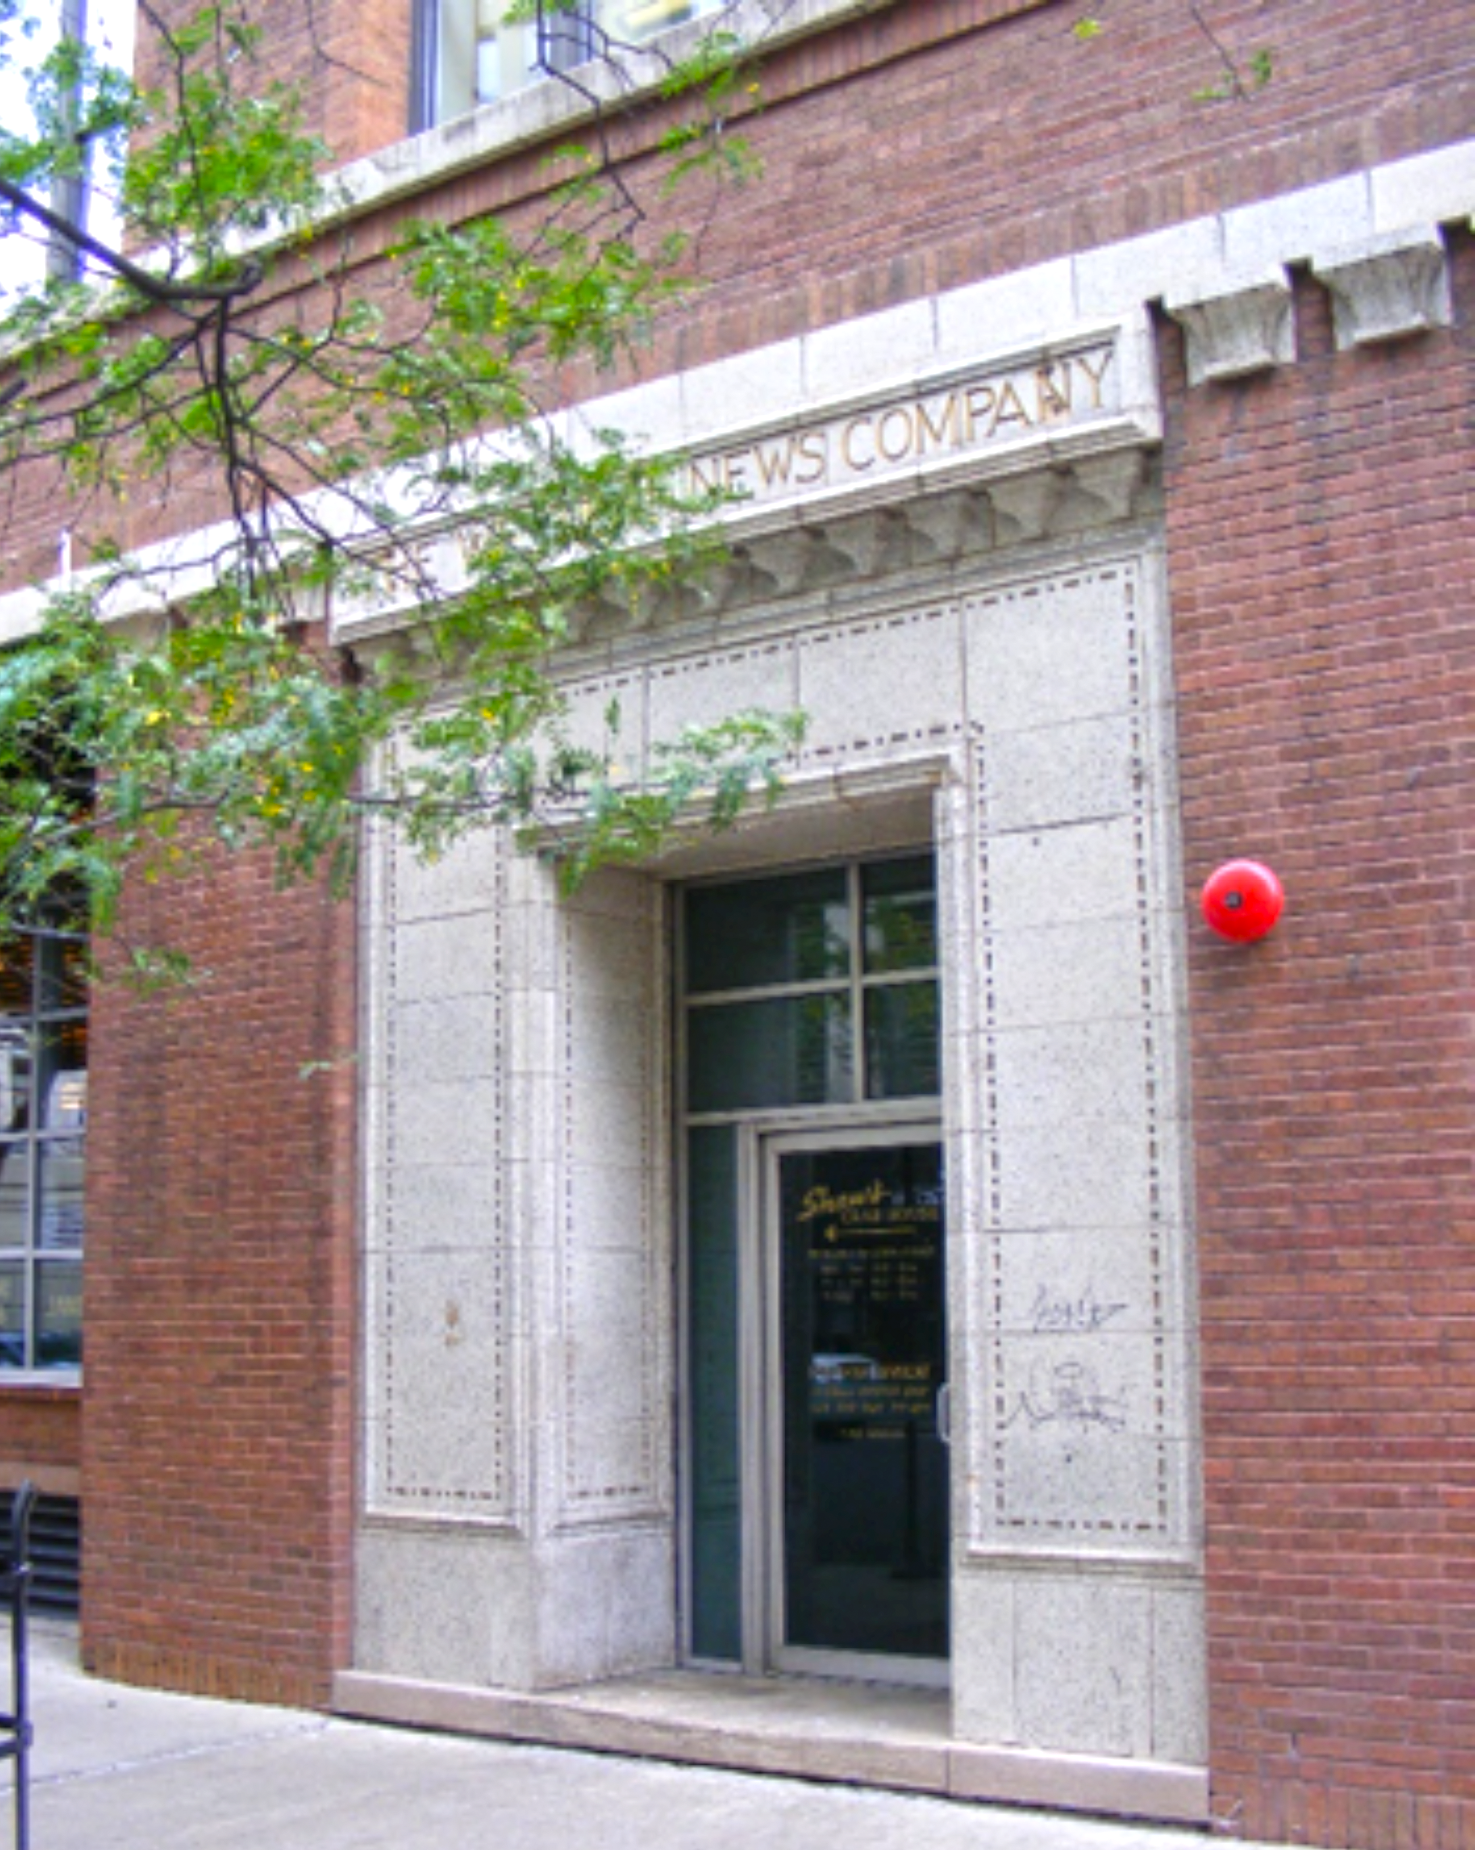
[0,0,1475,1850]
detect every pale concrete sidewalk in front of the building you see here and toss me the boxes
[0,1619,1236,1850]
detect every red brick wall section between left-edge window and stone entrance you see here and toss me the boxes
[83,857,357,1704]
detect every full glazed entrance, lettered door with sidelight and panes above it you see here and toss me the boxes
[679,851,948,1680]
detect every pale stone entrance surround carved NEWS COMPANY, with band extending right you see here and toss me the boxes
[339,144,1475,1819]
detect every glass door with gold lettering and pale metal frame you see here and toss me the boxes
[766,1127,949,1682]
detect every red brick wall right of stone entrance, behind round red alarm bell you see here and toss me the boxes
[1166,237,1475,1850]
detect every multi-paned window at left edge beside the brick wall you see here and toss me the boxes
[0,931,87,1369]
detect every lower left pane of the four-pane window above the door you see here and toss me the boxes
[687,993,851,1112]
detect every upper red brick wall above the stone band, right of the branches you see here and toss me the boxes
[647,0,1475,364]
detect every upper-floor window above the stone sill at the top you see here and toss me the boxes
[413,0,722,130]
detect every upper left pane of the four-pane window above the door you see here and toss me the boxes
[687,868,849,995]
